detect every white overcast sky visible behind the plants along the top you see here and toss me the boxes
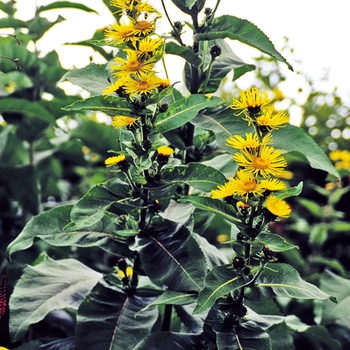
[2,0,350,104]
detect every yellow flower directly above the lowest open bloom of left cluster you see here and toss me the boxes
[111,50,155,78]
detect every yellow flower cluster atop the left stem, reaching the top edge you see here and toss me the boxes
[104,0,169,98]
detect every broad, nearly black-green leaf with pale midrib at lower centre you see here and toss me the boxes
[130,218,207,292]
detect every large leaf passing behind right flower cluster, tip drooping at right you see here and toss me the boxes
[191,107,339,177]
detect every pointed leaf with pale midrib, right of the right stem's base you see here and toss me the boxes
[253,263,331,300]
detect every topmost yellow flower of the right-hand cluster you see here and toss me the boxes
[230,87,271,116]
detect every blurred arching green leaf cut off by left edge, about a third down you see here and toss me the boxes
[0,97,56,124]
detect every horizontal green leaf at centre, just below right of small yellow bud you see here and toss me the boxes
[161,163,226,192]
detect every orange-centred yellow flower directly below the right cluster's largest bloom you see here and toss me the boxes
[230,170,265,201]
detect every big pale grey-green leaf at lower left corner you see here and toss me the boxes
[10,258,102,341]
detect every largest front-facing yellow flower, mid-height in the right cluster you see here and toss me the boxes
[233,146,287,178]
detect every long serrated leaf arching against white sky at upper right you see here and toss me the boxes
[194,15,293,70]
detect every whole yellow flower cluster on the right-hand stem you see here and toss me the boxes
[211,88,291,218]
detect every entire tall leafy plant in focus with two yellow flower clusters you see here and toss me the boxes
[7,0,337,350]
